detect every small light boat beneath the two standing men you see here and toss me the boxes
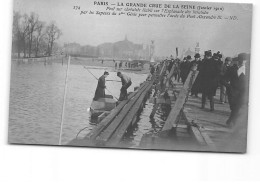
[90,95,117,118]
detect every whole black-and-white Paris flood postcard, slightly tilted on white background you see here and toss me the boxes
[8,0,253,153]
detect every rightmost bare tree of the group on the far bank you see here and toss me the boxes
[46,22,62,56]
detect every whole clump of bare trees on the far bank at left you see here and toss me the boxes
[13,12,62,58]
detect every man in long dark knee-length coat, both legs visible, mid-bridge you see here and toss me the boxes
[200,51,220,111]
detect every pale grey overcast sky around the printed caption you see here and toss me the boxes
[14,0,252,56]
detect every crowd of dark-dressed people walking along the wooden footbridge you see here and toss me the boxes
[151,50,248,127]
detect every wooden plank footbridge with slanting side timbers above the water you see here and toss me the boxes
[68,62,241,152]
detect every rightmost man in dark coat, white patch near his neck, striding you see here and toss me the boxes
[225,54,248,127]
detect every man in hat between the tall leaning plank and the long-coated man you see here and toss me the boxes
[191,53,202,97]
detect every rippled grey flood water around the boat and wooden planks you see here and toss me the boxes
[8,62,167,146]
